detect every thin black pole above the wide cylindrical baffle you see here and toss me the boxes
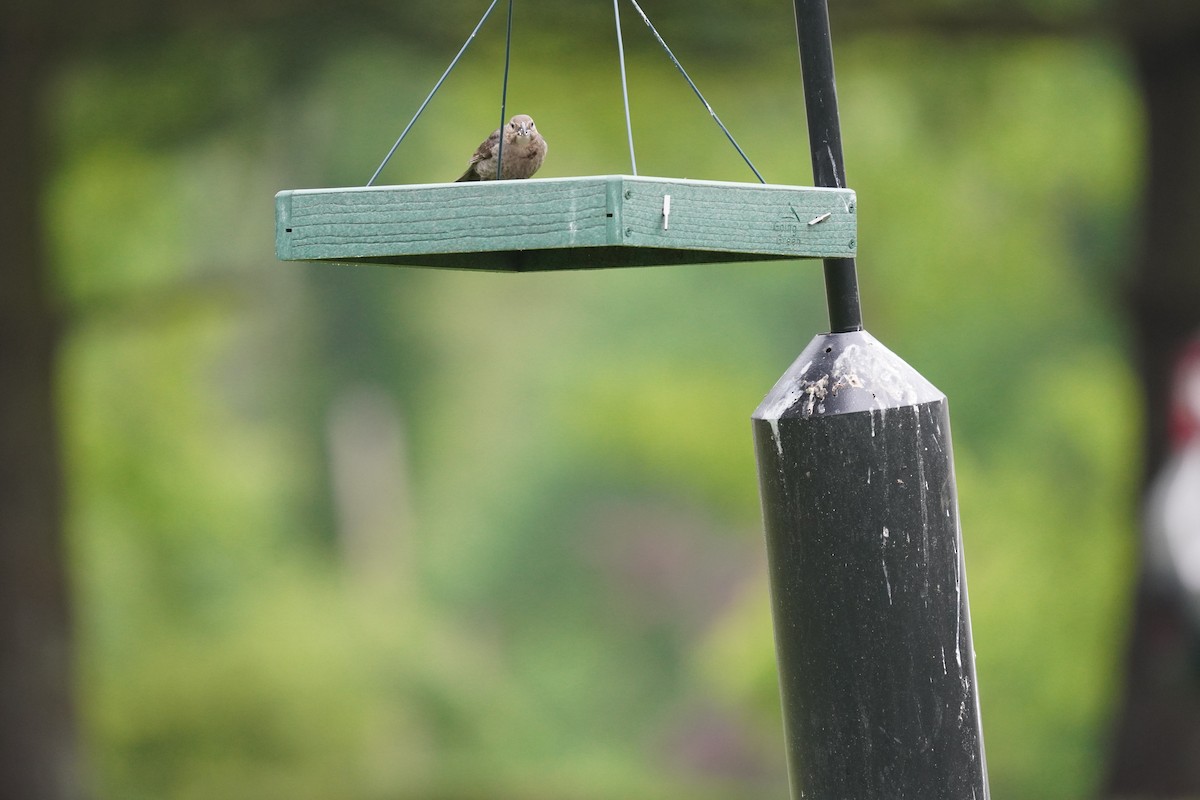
[796,0,863,333]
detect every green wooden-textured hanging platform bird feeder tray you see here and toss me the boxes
[275,175,857,272]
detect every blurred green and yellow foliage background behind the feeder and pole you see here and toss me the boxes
[7,0,1200,800]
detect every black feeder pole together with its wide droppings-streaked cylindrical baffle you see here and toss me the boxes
[754,0,989,800]
